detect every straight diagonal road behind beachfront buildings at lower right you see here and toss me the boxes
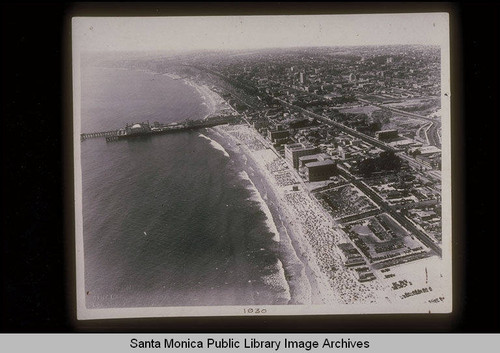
[338,168,442,257]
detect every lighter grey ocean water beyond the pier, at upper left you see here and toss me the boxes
[81,67,208,132]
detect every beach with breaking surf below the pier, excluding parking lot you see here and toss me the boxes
[205,124,392,306]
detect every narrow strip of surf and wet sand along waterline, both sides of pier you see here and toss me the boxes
[154,69,339,305]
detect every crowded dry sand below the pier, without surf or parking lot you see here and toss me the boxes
[208,125,382,304]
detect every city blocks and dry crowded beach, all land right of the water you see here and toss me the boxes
[92,45,444,303]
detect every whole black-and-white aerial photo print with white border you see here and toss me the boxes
[72,13,452,319]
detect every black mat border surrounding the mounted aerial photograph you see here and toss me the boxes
[0,2,500,333]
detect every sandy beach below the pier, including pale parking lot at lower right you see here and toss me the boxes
[203,125,450,312]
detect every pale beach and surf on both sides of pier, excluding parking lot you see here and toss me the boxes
[92,65,382,305]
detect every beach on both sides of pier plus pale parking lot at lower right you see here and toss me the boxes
[81,64,450,306]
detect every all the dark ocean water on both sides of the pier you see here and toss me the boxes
[81,68,290,308]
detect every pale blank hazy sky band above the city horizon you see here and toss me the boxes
[73,13,448,51]
